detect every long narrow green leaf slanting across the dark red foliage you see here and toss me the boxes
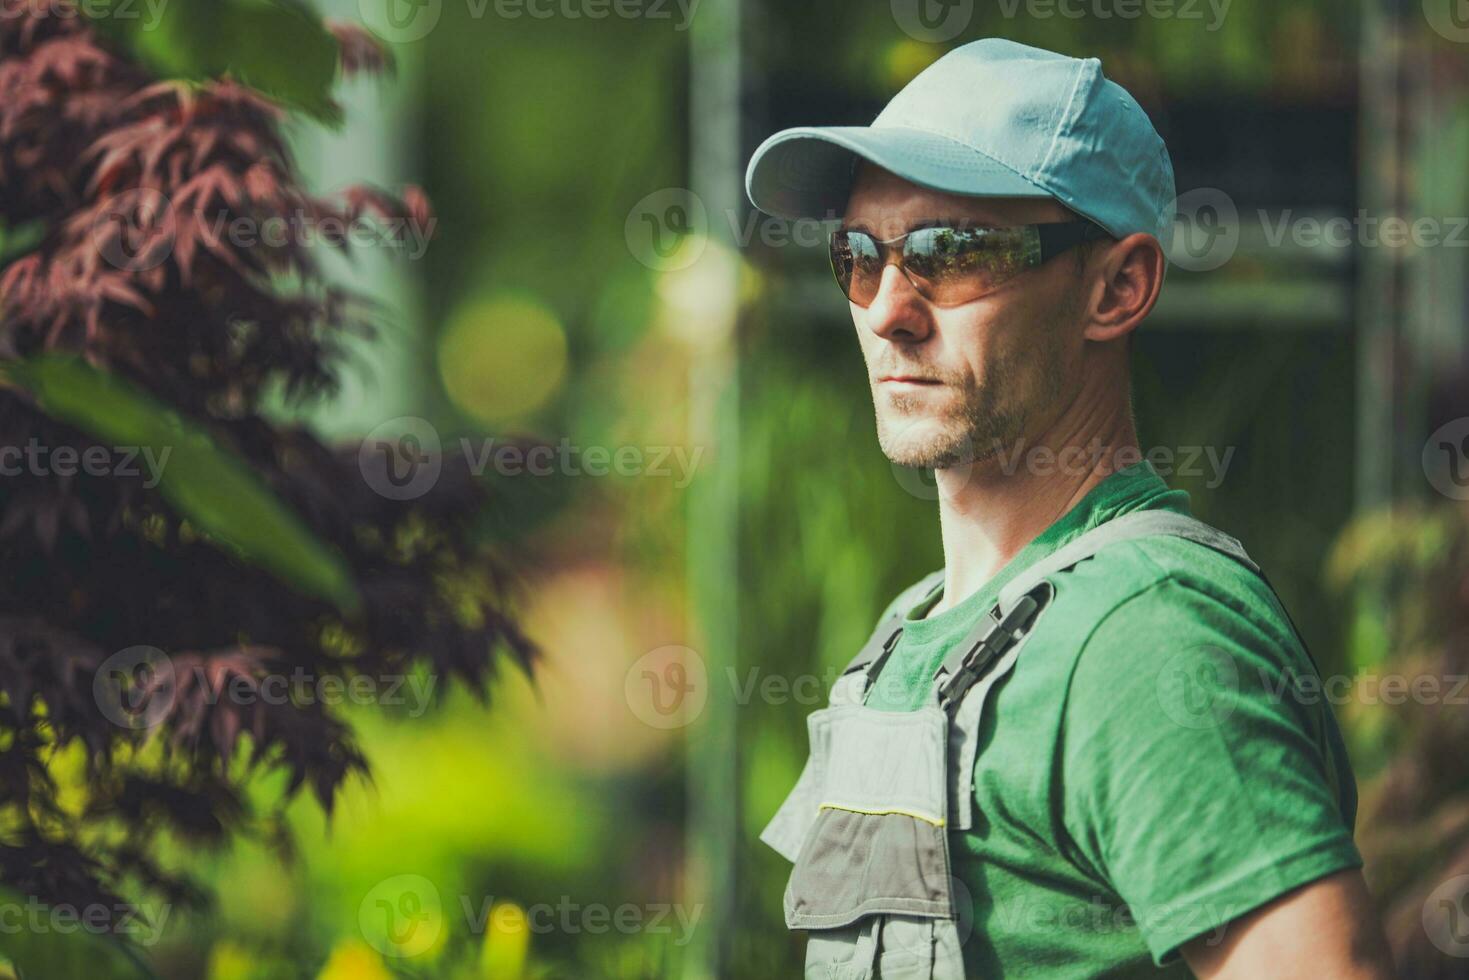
[0,354,361,613]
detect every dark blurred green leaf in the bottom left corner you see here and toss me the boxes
[0,889,157,980]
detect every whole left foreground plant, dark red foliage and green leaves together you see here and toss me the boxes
[0,0,532,976]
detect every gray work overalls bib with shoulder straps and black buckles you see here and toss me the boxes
[761,510,1259,980]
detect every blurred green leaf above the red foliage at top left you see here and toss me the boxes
[87,0,341,125]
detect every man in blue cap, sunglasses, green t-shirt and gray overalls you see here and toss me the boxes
[746,40,1390,980]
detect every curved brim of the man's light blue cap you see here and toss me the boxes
[745,126,1052,219]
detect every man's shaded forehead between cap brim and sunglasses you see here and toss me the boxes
[843,162,1072,235]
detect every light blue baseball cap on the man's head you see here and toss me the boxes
[745,38,1174,242]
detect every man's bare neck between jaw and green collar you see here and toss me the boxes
[928,382,1140,616]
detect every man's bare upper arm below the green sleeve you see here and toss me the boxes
[1181,868,1393,980]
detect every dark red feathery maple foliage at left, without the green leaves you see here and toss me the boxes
[0,0,530,922]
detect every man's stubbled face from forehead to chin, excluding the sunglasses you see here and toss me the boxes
[845,163,1087,469]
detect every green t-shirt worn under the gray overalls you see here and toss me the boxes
[867,461,1362,977]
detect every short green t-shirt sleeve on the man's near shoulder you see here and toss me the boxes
[1062,579,1362,964]
